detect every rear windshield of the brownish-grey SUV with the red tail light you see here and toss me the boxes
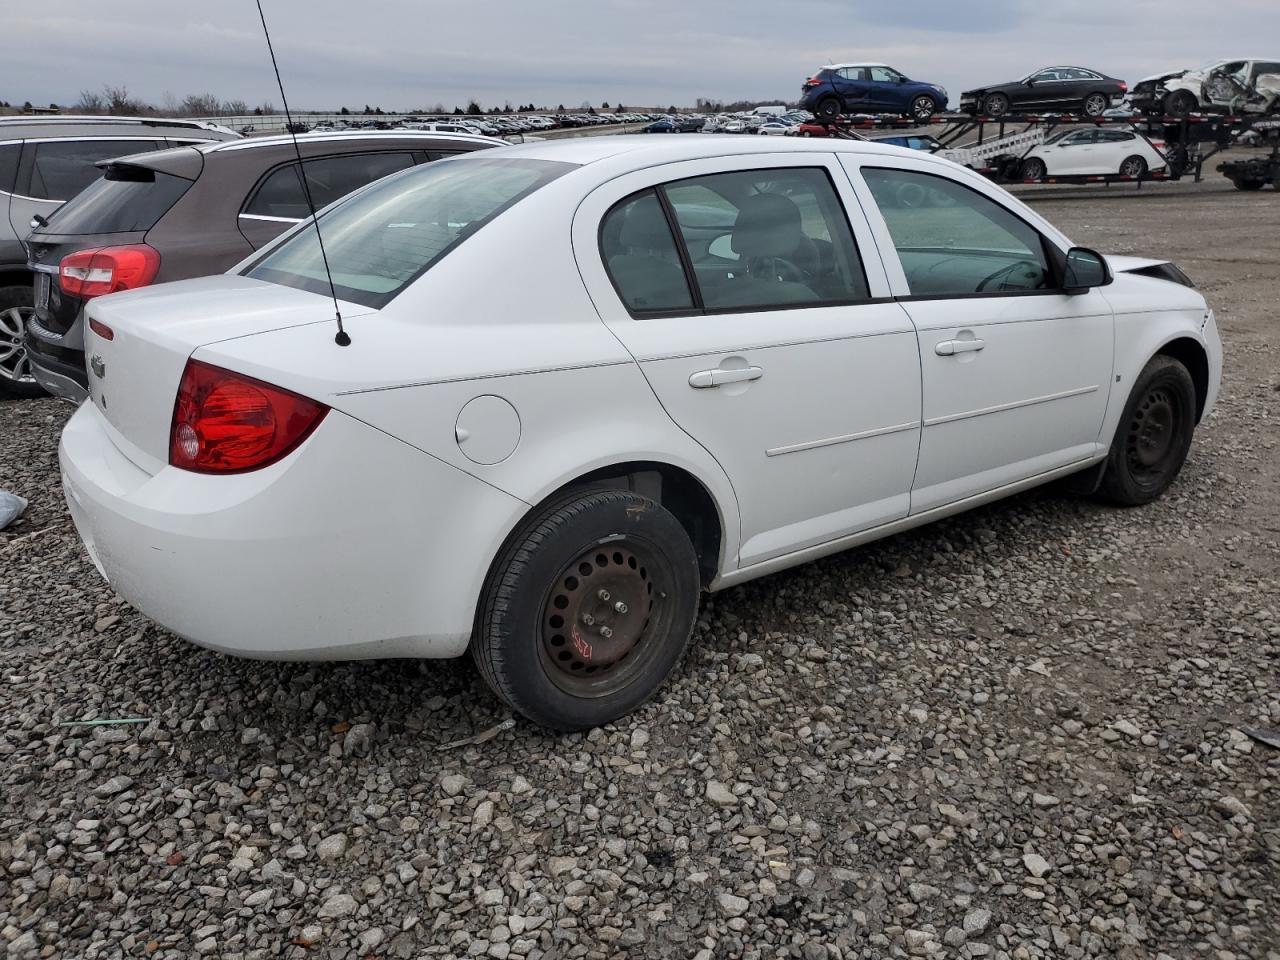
[44,164,192,236]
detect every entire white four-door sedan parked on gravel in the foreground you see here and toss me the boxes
[60,137,1221,730]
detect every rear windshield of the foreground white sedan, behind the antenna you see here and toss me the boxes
[244,156,573,307]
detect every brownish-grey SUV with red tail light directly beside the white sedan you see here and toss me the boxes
[26,131,496,403]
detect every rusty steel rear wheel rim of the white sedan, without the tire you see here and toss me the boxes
[538,536,672,698]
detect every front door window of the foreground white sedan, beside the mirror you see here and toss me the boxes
[863,168,1053,297]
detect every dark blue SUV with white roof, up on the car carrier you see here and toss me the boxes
[800,63,947,120]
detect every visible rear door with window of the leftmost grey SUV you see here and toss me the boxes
[9,137,164,256]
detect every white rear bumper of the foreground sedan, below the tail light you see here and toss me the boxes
[59,403,527,659]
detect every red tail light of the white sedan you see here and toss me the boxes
[169,360,329,474]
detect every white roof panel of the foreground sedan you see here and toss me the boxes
[471,133,921,166]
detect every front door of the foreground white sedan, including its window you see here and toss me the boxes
[845,157,1114,513]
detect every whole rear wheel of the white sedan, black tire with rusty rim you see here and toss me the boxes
[471,489,700,731]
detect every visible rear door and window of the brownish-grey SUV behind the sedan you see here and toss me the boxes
[238,150,415,248]
